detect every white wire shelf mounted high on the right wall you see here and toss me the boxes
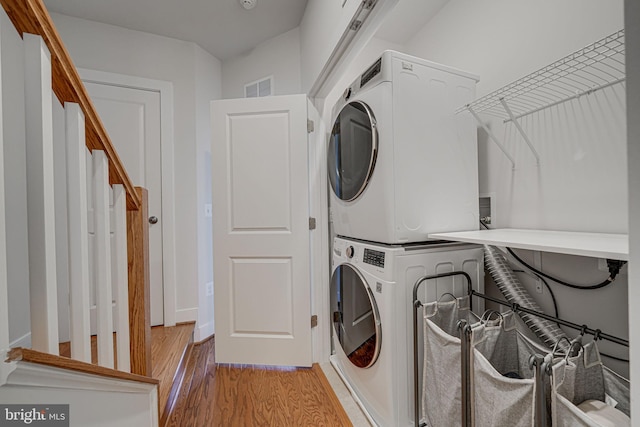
[456,30,625,123]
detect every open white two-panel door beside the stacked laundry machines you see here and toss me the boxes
[211,95,312,366]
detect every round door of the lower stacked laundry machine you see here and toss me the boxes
[330,264,382,368]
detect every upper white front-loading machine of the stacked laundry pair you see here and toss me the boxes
[327,51,478,243]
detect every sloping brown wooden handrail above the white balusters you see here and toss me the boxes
[0,0,141,210]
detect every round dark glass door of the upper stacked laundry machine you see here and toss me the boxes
[327,101,378,201]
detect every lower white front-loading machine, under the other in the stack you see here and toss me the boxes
[330,237,484,427]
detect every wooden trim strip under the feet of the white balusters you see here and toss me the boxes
[6,347,159,386]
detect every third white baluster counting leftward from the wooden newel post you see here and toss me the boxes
[65,103,91,363]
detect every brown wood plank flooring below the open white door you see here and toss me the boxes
[60,323,352,427]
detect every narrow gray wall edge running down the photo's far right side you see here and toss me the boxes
[624,0,640,427]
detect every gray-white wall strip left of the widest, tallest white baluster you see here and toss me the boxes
[0,10,31,347]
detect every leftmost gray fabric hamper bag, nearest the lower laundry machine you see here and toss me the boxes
[422,296,479,427]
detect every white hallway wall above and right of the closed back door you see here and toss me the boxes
[52,14,220,328]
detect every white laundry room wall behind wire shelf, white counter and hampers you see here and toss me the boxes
[390,0,628,374]
